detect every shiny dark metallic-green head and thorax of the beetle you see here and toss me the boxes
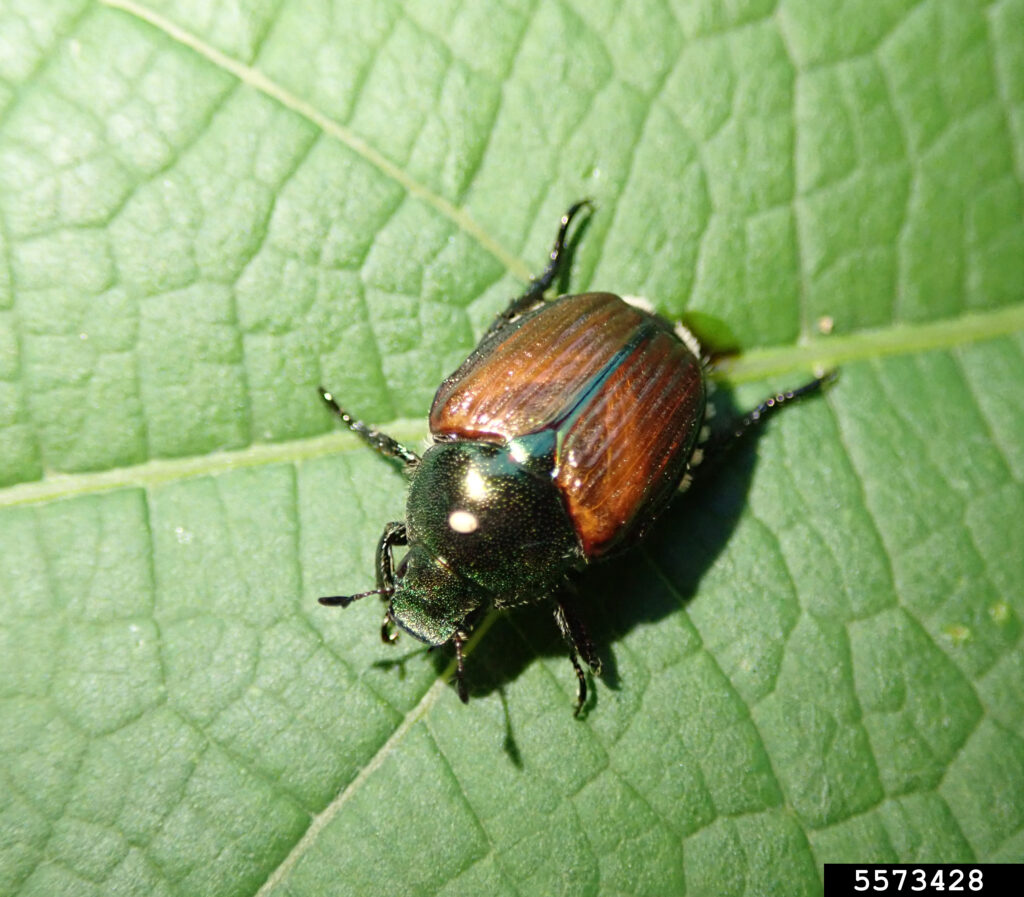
[391,437,580,644]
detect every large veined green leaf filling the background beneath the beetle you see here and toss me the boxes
[0,0,1024,895]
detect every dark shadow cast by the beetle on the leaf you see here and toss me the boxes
[401,386,763,749]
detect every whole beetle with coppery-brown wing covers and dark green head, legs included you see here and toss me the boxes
[319,200,833,715]
